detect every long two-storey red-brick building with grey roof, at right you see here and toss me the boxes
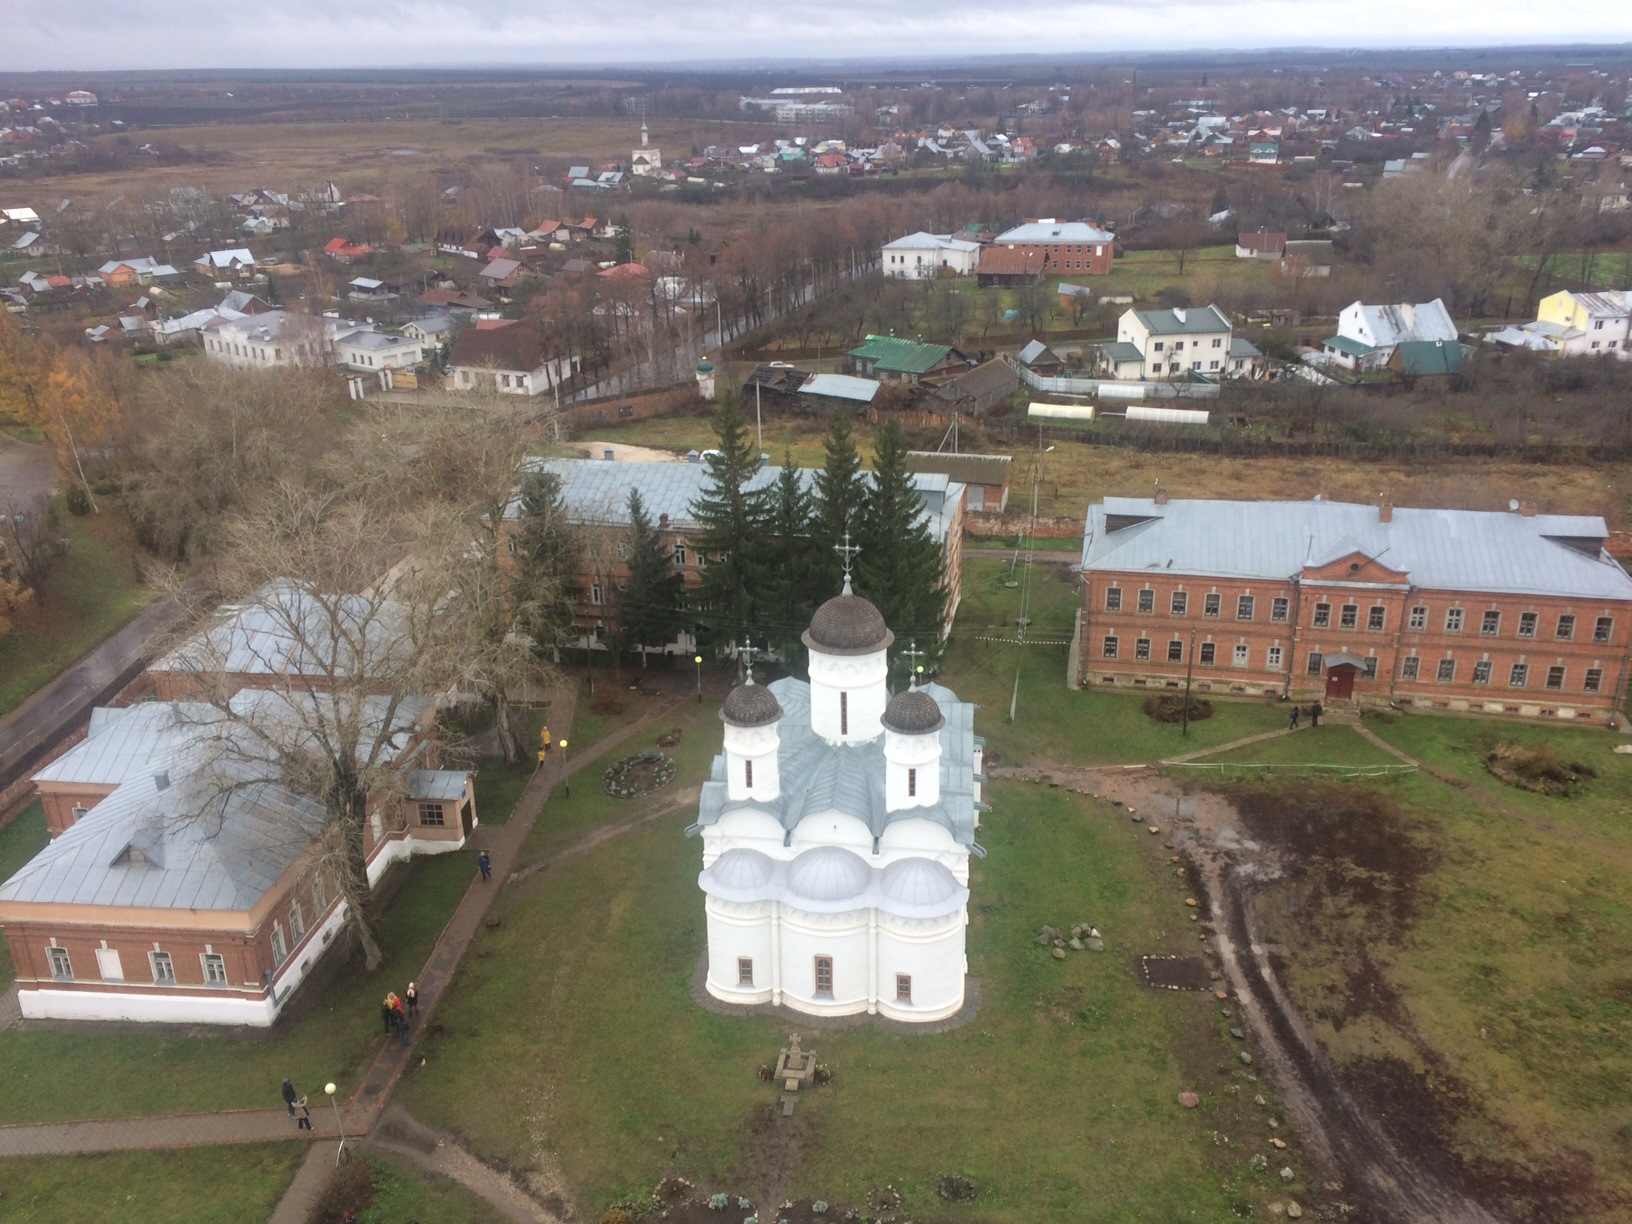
[1075,491,1632,725]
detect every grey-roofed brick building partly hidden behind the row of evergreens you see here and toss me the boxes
[508,456,965,658]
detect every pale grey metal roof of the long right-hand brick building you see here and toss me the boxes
[1082,498,1632,599]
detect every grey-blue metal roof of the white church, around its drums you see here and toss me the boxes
[697,677,976,845]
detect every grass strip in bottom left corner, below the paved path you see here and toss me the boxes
[0,1142,306,1224]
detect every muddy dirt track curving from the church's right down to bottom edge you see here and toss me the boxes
[991,765,1500,1224]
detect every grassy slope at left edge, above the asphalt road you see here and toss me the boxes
[0,498,153,724]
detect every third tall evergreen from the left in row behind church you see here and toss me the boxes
[690,400,769,646]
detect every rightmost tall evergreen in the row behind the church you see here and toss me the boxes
[855,418,947,654]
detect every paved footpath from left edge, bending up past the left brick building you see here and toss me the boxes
[0,690,692,1157]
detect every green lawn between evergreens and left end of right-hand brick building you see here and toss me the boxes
[940,555,1286,765]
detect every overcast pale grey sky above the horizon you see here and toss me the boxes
[9,0,1632,72]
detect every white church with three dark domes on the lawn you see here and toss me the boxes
[687,578,986,1023]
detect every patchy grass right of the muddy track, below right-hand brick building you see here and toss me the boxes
[1214,715,1632,1222]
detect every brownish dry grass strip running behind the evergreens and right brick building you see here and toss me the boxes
[567,412,1632,529]
